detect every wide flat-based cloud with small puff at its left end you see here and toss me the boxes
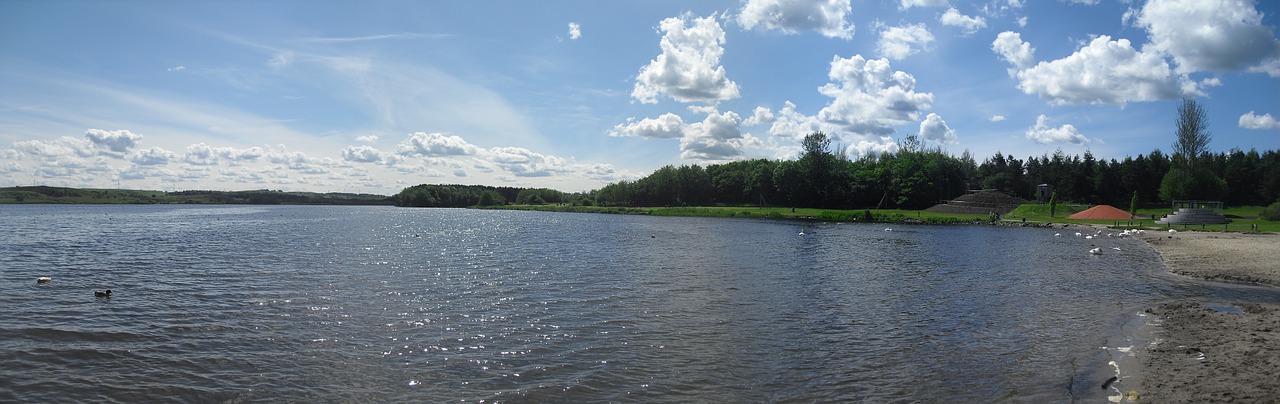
[992,32,1182,105]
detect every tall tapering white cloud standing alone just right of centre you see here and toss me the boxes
[631,14,739,104]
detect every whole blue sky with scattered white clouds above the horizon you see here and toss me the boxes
[0,0,1280,194]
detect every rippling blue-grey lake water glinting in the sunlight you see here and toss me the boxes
[0,206,1280,403]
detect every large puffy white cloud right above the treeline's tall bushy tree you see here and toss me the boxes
[818,55,933,136]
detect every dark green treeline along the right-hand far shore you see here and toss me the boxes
[590,132,1280,208]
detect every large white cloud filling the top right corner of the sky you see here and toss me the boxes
[1137,0,1280,77]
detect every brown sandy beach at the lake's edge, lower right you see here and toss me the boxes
[1137,231,1280,403]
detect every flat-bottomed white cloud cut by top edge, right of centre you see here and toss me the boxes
[737,0,854,40]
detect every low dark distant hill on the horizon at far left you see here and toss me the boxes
[0,185,396,205]
